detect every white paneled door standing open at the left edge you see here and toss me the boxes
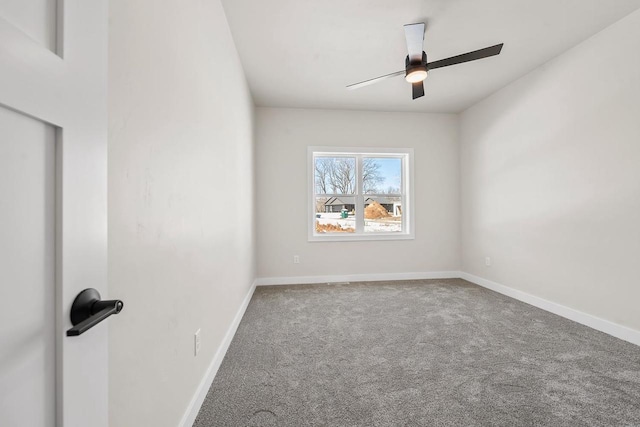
[0,0,108,427]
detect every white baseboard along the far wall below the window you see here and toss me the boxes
[257,271,460,286]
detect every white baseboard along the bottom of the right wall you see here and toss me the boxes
[459,272,640,345]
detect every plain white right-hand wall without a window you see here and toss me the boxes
[460,11,640,330]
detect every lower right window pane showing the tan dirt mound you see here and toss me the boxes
[364,195,402,233]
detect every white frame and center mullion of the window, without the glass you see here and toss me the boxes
[307,146,415,242]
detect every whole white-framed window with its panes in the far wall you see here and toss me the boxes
[308,147,413,241]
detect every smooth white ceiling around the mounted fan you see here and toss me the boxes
[222,0,640,112]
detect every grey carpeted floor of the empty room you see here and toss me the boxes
[194,279,640,427]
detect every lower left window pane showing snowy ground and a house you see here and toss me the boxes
[315,196,356,234]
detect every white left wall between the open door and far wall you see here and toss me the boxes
[109,0,255,427]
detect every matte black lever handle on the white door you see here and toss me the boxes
[67,288,124,337]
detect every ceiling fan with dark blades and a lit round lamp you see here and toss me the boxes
[347,22,503,99]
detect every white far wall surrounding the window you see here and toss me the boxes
[256,108,460,282]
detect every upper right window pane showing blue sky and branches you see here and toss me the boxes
[362,157,402,194]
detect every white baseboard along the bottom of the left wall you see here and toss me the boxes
[179,280,257,427]
